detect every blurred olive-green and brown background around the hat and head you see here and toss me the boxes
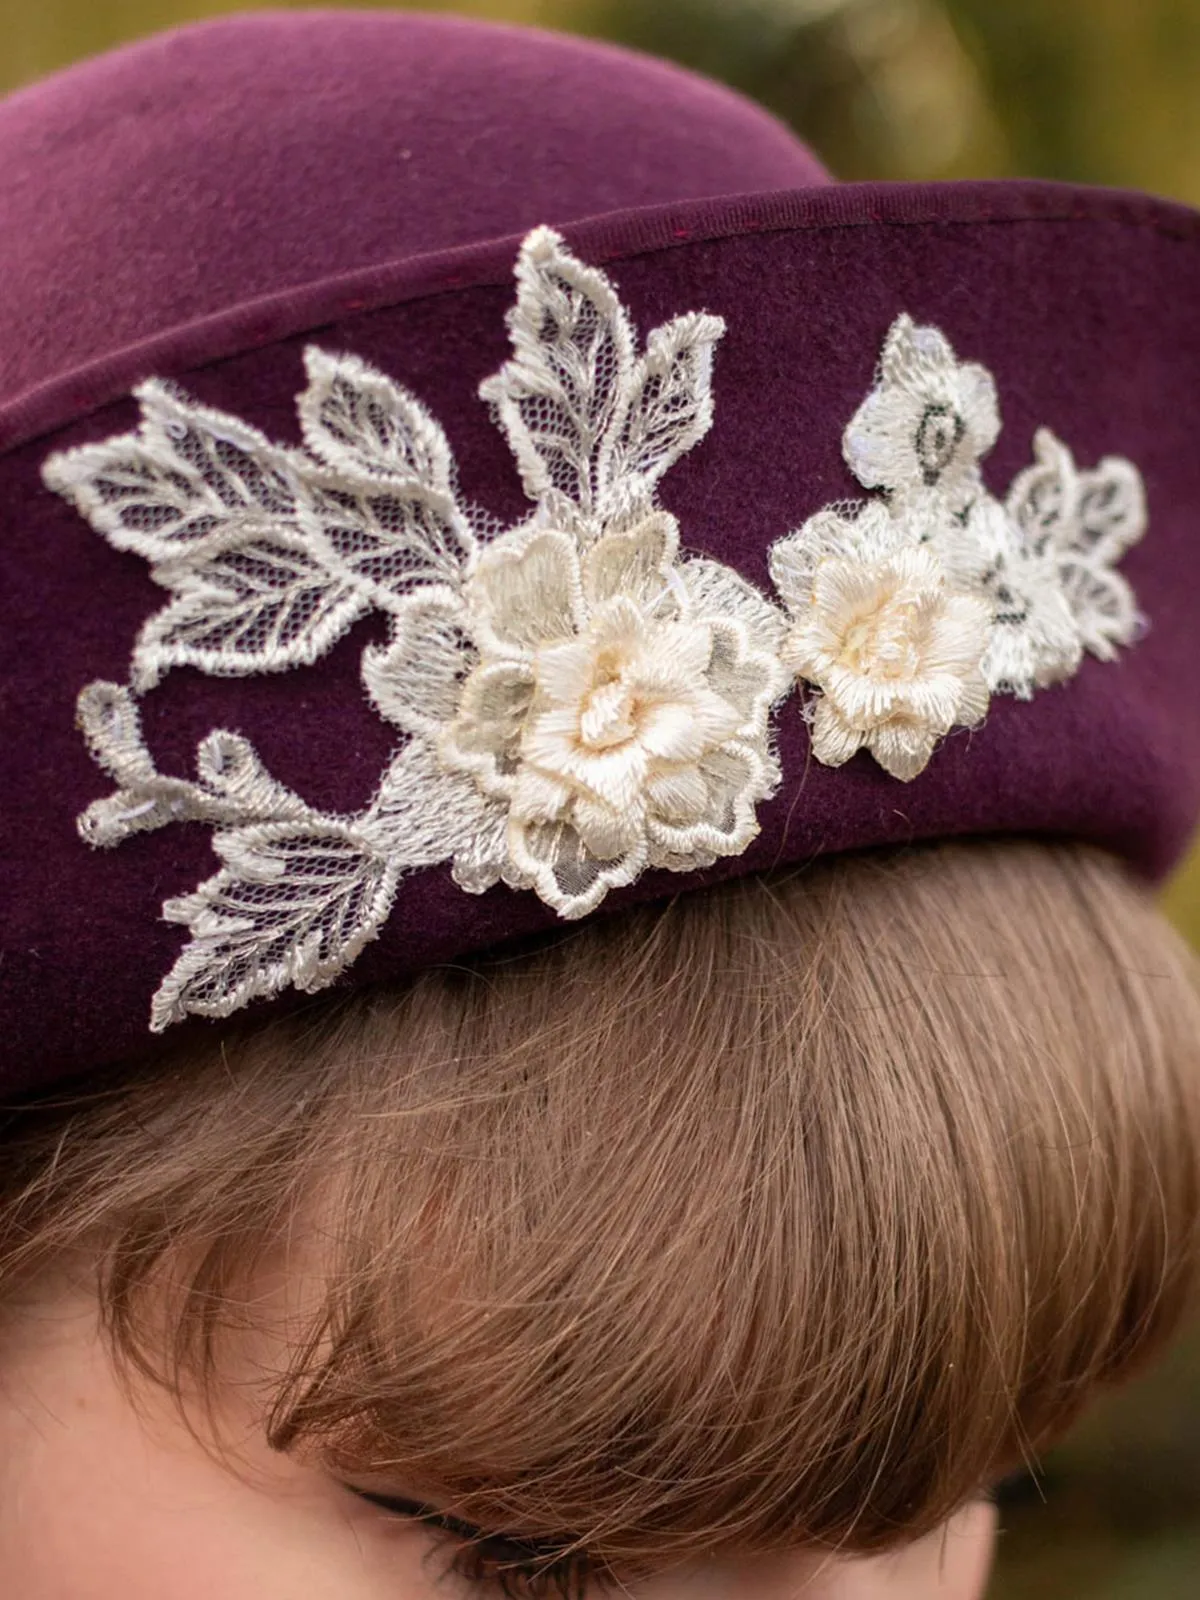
[0,0,1200,1600]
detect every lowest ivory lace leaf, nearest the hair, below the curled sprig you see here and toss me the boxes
[150,818,398,1034]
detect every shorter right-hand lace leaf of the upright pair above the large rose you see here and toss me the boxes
[598,312,725,517]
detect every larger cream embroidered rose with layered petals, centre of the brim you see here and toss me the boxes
[437,512,786,914]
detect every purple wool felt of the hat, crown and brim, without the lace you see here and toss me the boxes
[0,14,1200,1093]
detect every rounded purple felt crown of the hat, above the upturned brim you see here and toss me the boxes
[0,13,829,405]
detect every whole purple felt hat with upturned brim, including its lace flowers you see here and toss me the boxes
[0,13,1200,1093]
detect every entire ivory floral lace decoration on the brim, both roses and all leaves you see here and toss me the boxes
[43,229,1146,1032]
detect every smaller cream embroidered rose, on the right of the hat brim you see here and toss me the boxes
[771,504,990,781]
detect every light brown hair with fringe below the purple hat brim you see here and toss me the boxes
[0,838,1200,1566]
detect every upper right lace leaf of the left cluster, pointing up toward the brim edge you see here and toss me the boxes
[299,346,454,494]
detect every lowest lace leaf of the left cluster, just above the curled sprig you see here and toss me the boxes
[133,528,370,690]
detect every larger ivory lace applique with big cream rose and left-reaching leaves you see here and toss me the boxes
[43,229,789,1030]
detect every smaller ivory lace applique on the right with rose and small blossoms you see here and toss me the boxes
[771,315,1146,779]
